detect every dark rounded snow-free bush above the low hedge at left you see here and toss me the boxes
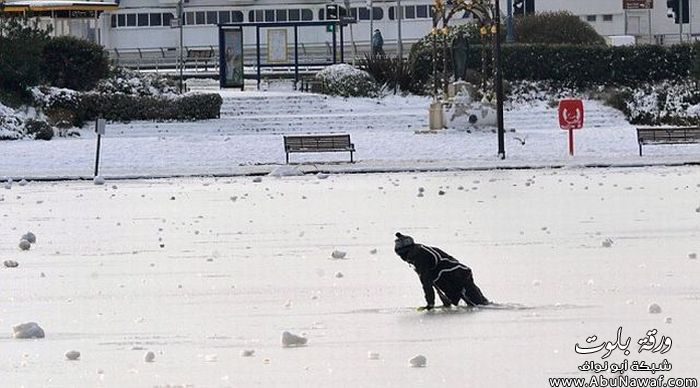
[41,36,109,90]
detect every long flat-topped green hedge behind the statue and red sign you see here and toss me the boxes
[410,41,700,91]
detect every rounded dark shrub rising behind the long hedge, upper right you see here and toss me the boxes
[513,11,605,45]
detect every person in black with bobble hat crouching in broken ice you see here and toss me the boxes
[394,233,489,310]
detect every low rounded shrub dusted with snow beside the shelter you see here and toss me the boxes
[316,63,379,97]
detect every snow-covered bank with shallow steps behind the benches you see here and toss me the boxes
[0,86,700,178]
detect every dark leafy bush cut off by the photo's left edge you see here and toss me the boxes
[0,16,49,99]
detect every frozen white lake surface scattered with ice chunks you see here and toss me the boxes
[0,167,700,388]
